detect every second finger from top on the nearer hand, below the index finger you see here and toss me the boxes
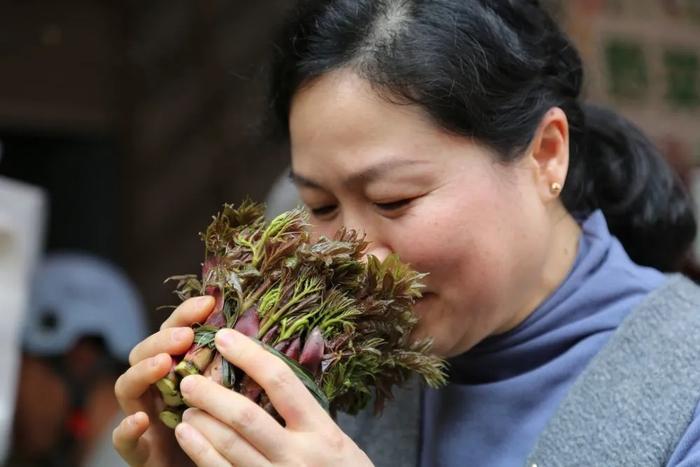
[180,375,287,461]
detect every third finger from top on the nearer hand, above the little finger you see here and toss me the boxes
[182,409,271,467]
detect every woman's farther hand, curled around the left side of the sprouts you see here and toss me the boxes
[112,296,214,467]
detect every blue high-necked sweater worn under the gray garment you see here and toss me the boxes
[421,211,700,467]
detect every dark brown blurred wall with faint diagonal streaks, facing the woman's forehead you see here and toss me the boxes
[123,0,289,326]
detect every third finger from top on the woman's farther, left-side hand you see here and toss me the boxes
[114,354,172,414]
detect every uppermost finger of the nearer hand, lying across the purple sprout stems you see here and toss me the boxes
[215,329,327,429]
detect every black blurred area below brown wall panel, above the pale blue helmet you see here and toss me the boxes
[0,130,120,263]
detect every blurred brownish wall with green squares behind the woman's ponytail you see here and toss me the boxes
[560,0,700,172]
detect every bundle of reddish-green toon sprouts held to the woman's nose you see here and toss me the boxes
[156,201,445,427]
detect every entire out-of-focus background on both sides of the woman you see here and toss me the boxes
[0,0,700,466]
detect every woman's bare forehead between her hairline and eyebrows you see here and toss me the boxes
[290,71,508,187]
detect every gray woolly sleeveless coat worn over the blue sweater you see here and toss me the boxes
[338,275,700,467]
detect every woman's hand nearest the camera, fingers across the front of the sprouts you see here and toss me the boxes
[175,329,372,467]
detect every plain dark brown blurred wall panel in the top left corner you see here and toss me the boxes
[0,0,125,134]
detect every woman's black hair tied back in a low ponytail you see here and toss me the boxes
[270,0,696,270]
